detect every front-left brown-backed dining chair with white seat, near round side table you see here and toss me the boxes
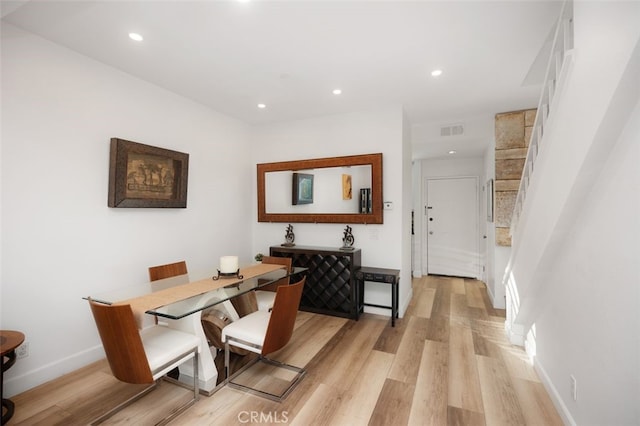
[89,299,200,425]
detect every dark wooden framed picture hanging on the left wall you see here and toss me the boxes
[107,138,189,208]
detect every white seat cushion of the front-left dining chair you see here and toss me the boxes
[140,325,200,378]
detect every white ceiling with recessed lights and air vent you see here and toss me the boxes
[2,0,561,159]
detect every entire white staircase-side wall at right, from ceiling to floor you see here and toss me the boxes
[507,1,640,425]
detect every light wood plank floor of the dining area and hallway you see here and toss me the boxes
[10,276,562,426]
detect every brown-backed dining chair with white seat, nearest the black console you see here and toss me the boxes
[222,277,306,402]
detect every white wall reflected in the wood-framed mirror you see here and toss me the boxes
[265,165,371,213]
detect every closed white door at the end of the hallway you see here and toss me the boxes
[424,177,480,278]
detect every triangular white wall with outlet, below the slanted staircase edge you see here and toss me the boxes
[535,95,640,425]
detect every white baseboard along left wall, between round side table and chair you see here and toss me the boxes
[3,345,105,398]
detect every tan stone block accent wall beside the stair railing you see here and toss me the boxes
[494,109,536,247]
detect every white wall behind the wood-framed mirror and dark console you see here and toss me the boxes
[252,106,411,315]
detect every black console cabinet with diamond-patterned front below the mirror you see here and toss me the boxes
[269,246,361,319]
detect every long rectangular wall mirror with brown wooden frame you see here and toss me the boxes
[257,153,383,224]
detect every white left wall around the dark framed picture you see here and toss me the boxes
[0,23,254,396]
